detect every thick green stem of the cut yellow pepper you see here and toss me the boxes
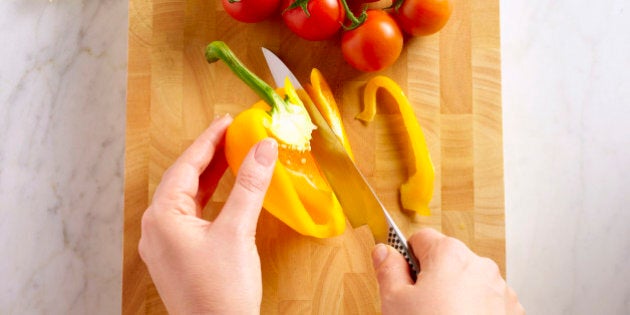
[206,41,288,112]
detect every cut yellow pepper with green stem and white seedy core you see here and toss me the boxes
[206,42,346,238]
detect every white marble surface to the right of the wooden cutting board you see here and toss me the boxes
[501,0,630,314]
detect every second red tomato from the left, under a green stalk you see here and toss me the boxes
[282,0,346,40]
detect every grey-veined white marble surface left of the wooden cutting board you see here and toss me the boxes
[0,0,127,314]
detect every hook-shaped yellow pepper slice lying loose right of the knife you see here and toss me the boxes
[356,76,435,215]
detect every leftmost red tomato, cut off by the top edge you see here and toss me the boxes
[222,0,280,23]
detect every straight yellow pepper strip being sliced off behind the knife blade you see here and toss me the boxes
[304,68,354,161]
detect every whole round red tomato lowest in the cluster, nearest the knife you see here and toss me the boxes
[341,10,403,72]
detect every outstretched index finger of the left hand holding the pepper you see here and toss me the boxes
[153,116,232,215]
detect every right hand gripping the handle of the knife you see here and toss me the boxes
[372,229,525,315]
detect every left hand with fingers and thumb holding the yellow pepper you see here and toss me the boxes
[138,116,278,314]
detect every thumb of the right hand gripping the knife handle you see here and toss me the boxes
[372,244,413,296]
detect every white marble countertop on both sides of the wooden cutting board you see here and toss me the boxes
[0,0,630,314]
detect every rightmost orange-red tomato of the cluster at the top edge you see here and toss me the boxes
[393,0,453,36]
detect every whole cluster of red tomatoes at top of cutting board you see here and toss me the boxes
[222,0,453,72]
